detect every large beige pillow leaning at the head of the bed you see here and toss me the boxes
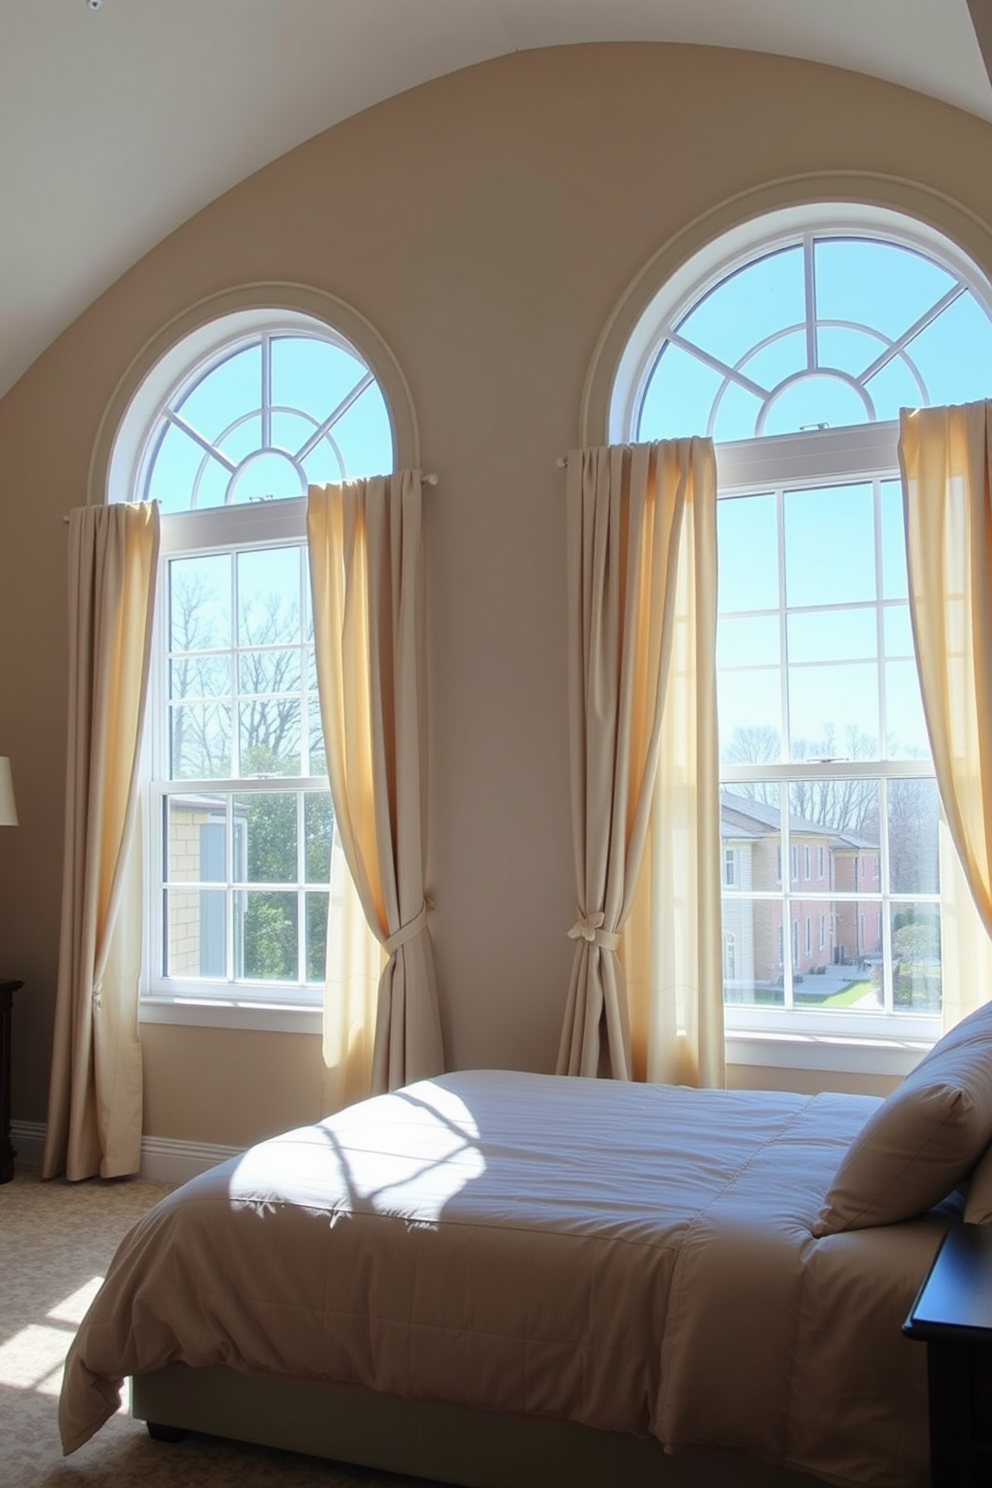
[814,1003,992,1235]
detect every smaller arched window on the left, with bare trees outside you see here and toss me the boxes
[109,296,404,1021]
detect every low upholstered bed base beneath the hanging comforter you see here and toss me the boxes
[131,1364,824,1488]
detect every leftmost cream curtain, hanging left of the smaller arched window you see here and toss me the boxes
[42,503,159,1180]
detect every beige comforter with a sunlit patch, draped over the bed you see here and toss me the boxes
[59,1071,946,1488]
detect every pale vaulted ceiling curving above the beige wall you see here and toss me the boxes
[0,0,992,396]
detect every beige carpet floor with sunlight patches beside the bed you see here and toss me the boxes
[0,1162,443,1488]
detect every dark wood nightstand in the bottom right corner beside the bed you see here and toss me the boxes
[903,1223,992,1488]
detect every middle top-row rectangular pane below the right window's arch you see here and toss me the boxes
[784,484,875,606]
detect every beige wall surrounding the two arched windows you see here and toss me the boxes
[0,45,992,1143]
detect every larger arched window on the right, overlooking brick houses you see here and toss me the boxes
[608,205,992,1033]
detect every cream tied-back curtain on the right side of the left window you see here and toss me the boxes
[306,470,445,1106]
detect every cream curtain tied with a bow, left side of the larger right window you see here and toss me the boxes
[558,439,723,1085]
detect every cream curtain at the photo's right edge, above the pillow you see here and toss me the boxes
[900,402,992,1027]
